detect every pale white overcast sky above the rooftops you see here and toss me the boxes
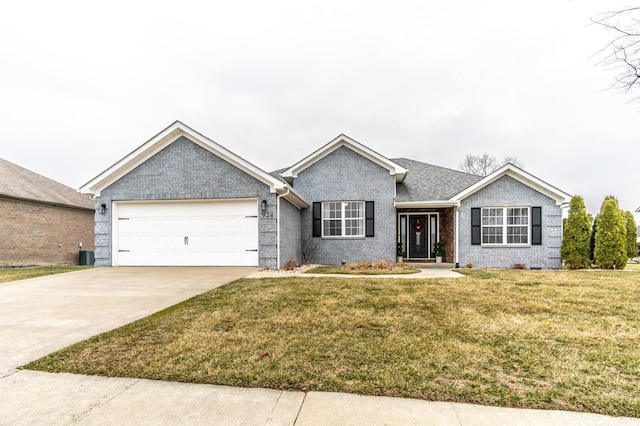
[0,0,640,213]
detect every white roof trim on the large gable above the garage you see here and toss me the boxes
[80,121,308,208]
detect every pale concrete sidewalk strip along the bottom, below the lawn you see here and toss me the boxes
[0,371,640,426]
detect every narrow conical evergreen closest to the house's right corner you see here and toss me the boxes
[561,195,591,269]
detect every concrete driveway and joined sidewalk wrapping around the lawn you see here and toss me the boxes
[0,268,640,425]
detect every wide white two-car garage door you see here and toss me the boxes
[113,199,258,266]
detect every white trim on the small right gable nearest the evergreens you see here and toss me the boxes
[451,163,571,206]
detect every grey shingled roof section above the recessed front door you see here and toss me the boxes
[392,158,482,207]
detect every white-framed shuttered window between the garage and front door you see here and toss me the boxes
[322,201,365,237]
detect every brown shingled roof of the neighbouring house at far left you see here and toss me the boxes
[0,158,94,210]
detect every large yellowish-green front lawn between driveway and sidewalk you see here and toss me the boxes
[26,269,640,417]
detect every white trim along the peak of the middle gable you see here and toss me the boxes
[281,135,407,182]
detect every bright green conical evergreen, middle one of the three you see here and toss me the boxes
[593,197,627,269]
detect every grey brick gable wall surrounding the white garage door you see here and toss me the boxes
[95,136,278,268]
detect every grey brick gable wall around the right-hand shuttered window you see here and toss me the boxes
[459,176,562,269]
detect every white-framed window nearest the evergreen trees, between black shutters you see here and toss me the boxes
[481,207,529,244]
